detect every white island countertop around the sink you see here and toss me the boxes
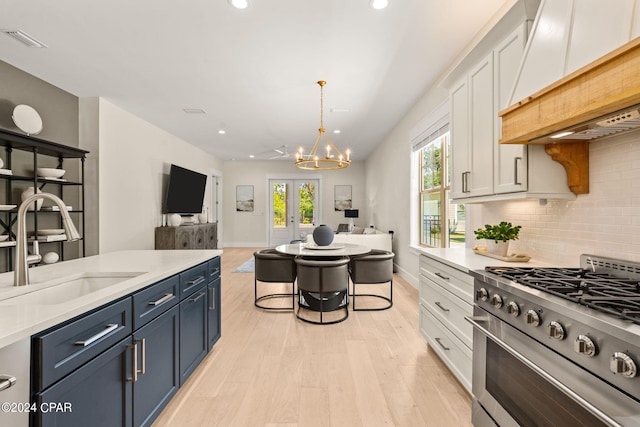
[0,250,222,348]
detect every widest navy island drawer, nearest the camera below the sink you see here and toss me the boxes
[33,298,133,391]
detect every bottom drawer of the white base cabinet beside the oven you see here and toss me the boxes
[420,305,472,393]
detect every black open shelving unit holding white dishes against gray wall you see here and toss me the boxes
[0,129,89,271]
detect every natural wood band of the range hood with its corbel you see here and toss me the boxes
[498,37,640,194]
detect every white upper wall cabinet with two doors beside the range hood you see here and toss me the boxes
[450,22,575,203]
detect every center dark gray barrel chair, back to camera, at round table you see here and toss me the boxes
[296,257,349,325]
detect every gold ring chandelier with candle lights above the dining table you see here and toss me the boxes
[296,80,351,170]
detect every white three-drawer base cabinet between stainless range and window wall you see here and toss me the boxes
[419,255,473,393]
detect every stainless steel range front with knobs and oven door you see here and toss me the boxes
[467,258,640,427]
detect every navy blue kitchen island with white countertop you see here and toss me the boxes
[0,250,222,426]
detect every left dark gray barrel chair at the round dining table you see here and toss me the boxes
[253,249,296,311]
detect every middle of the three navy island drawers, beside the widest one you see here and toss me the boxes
[133,275,180,329]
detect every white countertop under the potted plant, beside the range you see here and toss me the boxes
[417,248,552,273]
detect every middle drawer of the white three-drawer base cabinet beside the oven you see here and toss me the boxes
[420,277,473,348]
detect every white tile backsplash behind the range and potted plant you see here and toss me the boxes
[467,132,640,266]
